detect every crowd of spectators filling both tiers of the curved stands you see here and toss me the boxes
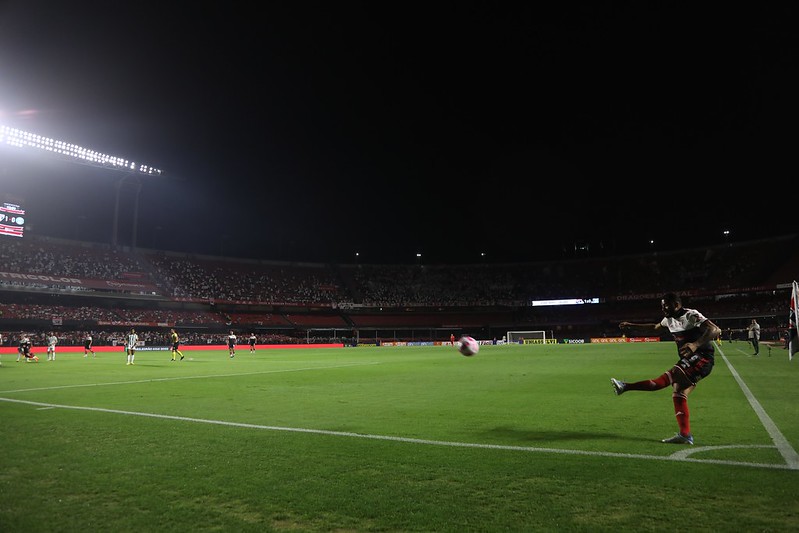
[0,236,799,343]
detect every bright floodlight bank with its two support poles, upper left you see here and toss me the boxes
[0,124,163,248]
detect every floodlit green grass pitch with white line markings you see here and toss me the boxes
[0,343,799,532]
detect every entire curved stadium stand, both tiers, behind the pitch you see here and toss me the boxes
[0,235,799,344]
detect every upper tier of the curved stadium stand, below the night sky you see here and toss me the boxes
[0,231,799,308]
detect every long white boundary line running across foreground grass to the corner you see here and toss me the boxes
[0,398,796,470]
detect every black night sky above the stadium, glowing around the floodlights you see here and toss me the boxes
[0,0,799,263]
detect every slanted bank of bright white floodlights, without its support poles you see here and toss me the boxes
[0,124,162,176]
